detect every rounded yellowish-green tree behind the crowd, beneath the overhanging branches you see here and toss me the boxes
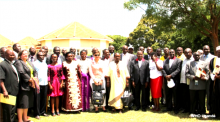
[126,16,174,51]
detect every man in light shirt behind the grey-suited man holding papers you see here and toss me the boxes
[200,45,215,113]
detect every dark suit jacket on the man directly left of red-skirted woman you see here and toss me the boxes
[130,60,150,85]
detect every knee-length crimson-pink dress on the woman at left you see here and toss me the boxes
[48,64,65,97]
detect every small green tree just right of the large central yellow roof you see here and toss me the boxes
[107,35,127,53]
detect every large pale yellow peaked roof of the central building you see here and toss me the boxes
[39,22,112,41]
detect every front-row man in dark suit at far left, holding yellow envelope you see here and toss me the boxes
[0,50,19,122]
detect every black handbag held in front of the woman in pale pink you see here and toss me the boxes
[92,83,104,105]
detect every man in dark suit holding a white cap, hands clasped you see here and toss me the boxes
[162,49,182,114]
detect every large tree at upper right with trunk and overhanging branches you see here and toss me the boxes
[124,0,220,54]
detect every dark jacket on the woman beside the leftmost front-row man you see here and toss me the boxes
[14,60,37,91]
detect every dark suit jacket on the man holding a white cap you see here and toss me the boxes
[162,58,182,85]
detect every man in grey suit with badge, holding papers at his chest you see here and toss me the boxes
[186,52,209,118]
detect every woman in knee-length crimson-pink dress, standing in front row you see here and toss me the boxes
[48,54,65,116]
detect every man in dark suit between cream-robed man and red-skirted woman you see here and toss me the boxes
[131,51,150,111]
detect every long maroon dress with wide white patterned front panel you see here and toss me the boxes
[62,61,82,111]
